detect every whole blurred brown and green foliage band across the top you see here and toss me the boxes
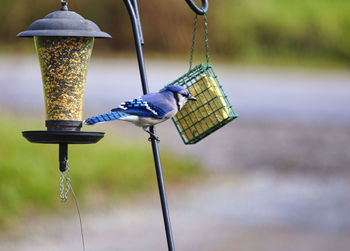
[0,0,350,64]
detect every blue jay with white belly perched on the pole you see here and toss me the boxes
[84,85,197,140]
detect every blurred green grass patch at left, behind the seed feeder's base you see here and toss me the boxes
[0,113,200,227]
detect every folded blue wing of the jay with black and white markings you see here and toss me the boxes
[112,98,168,119]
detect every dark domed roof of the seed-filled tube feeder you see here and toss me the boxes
[17,3,111,38]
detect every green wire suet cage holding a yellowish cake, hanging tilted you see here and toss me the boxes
[170,64,238,144]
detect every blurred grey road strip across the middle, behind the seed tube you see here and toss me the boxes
[0,56,350,124]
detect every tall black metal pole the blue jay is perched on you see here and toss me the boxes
[124,0,175,251]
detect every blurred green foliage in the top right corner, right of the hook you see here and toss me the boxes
[213,0,350,64]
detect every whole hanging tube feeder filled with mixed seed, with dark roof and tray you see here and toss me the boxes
[17,1,111,172]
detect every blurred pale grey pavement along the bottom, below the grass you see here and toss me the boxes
[0,173,350,251]
